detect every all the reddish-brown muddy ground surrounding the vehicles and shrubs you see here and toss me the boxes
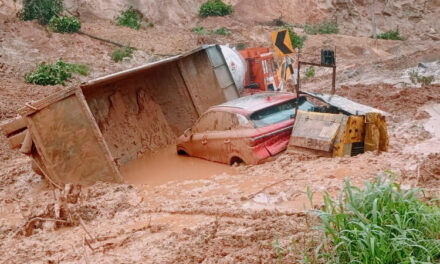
[0,0,440,264]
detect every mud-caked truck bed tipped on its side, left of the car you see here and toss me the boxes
[2,45,239,184]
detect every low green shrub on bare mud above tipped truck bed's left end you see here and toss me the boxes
[25,59,88,85]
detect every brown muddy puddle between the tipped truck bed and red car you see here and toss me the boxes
[121,145,236,186]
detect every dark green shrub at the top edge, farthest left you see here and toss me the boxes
[19,0,63,25]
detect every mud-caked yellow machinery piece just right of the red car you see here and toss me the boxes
[289,111,388,157]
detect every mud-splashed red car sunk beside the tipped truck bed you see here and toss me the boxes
[177,92,314,164]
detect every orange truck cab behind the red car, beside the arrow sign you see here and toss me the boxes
[240,47,279,95]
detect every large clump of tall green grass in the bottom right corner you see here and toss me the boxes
[309,176,440,264]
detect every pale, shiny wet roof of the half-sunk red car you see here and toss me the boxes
[209,92,296,115]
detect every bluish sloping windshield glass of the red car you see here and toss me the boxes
[250,97,315,127]
